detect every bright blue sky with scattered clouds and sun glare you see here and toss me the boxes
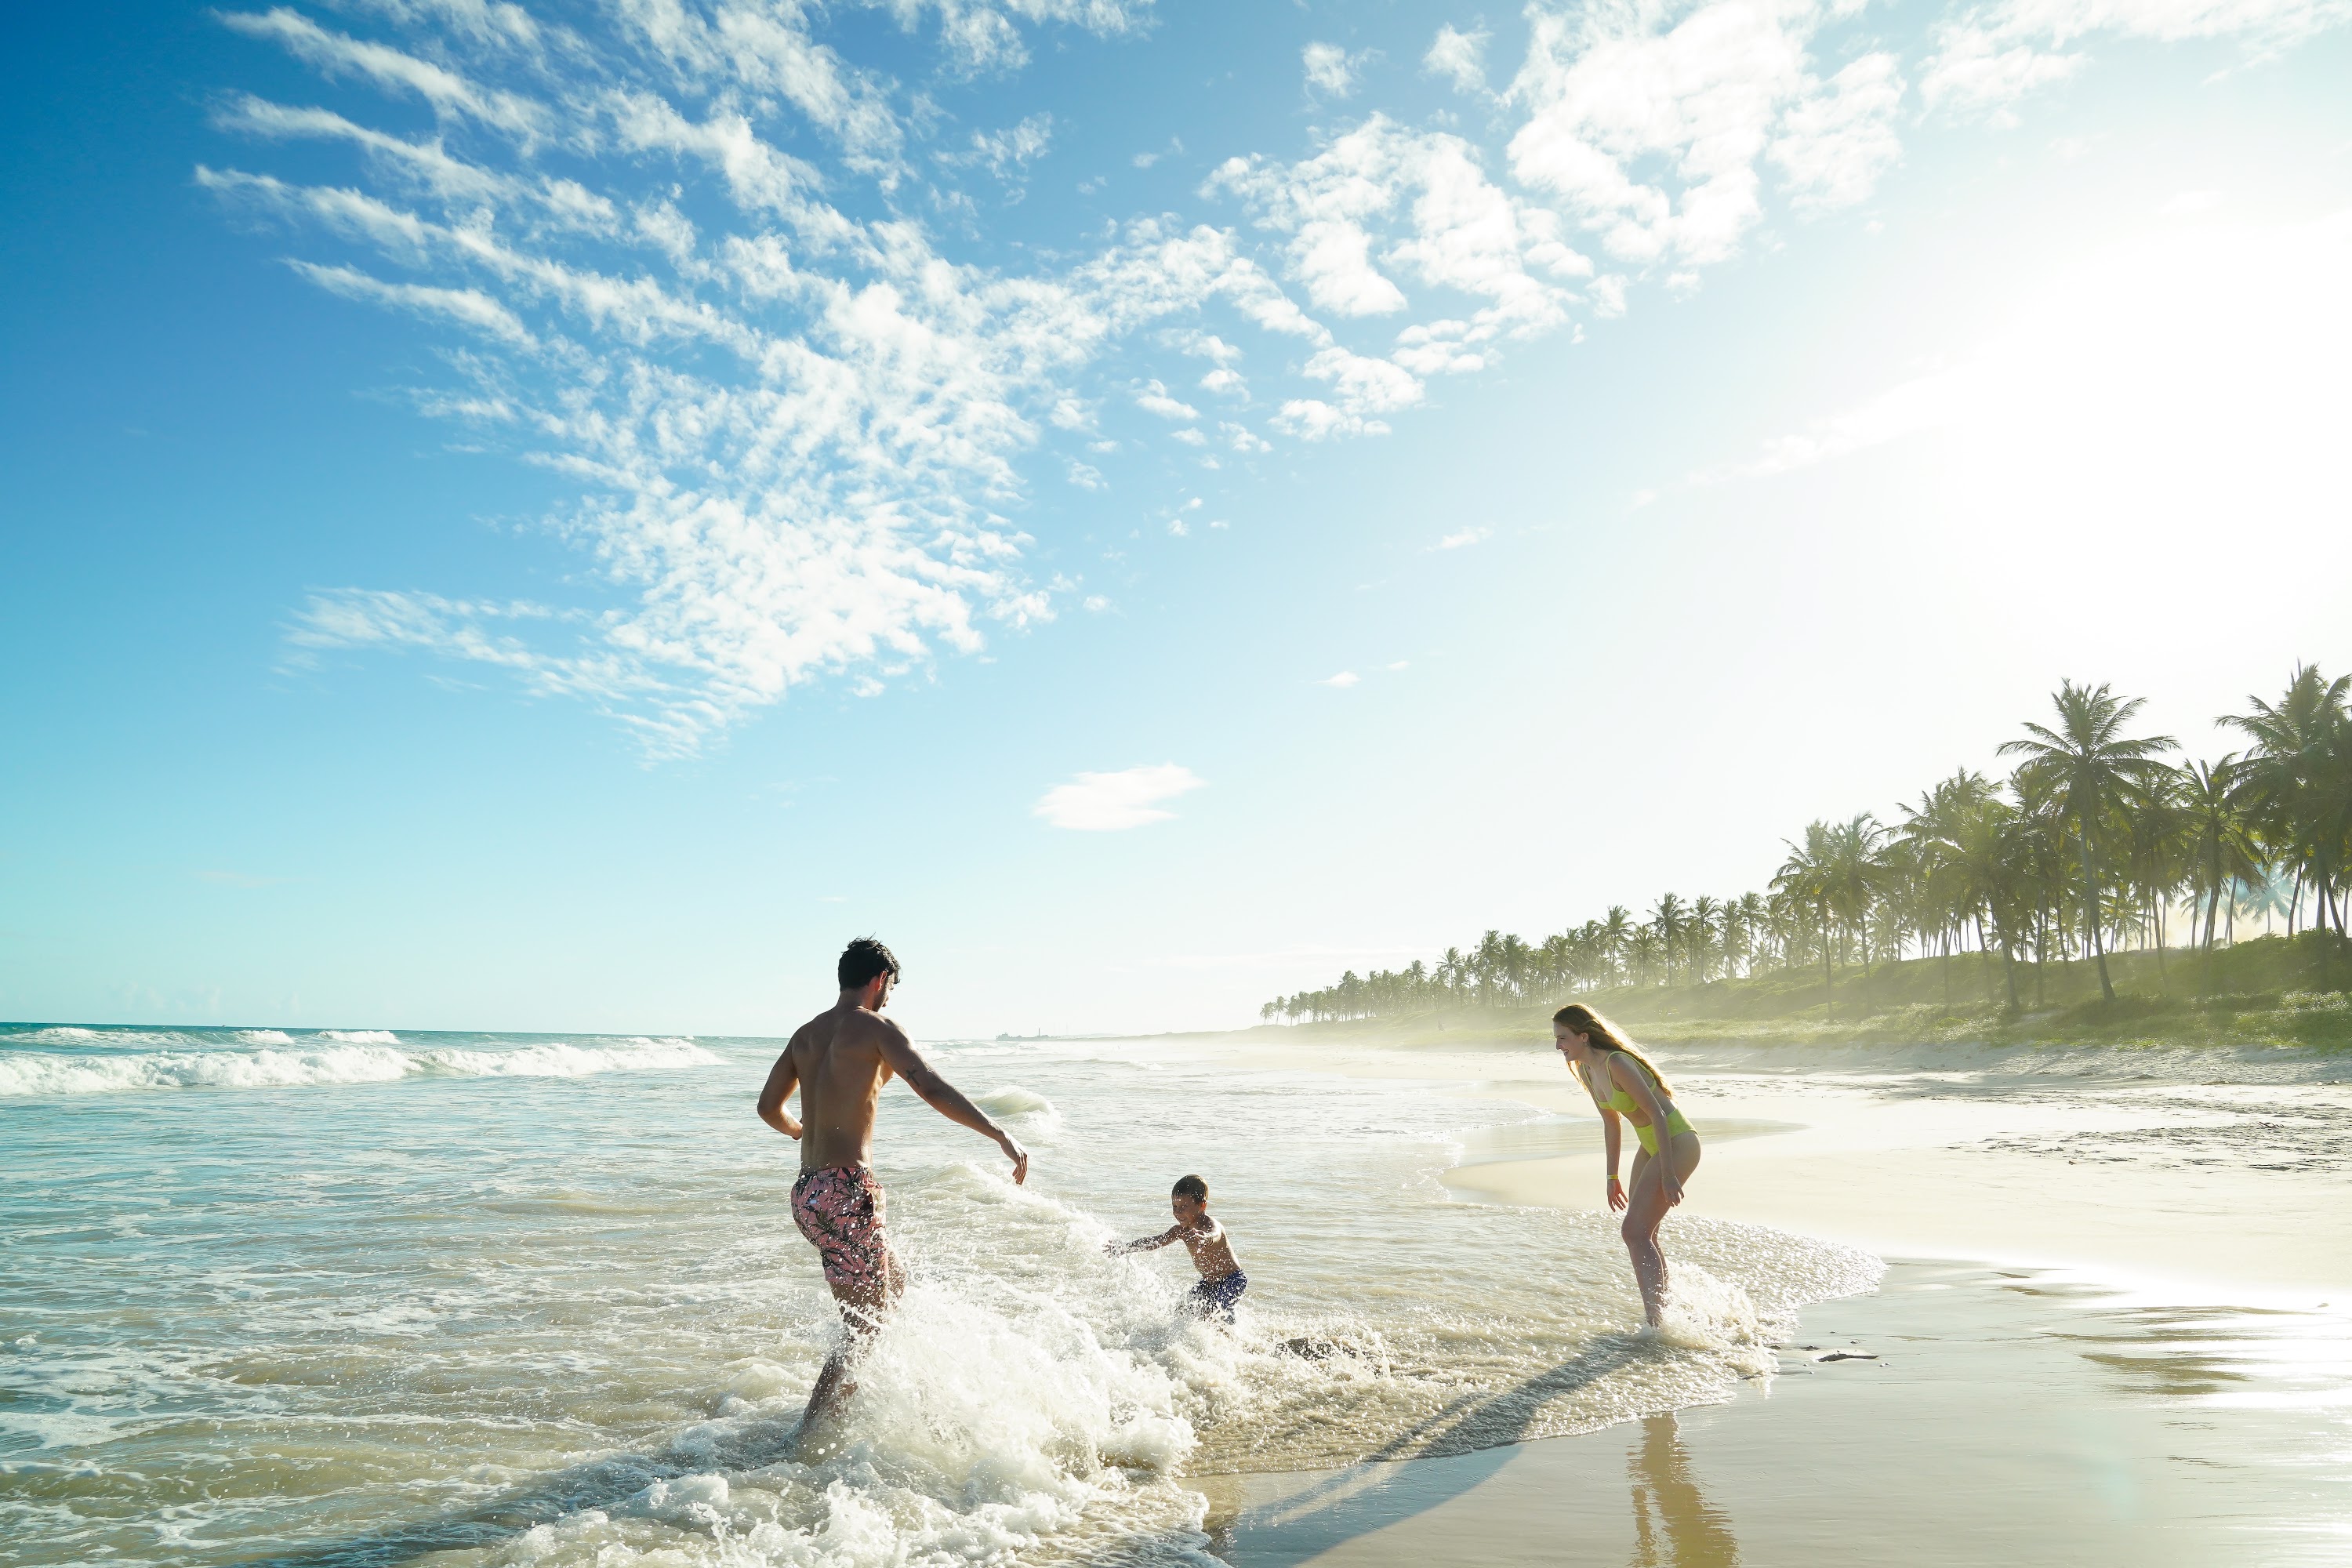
[0,0,2352,1039]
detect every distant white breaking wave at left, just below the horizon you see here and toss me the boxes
[0,1036,720,1095]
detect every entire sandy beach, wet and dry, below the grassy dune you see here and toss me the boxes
[1195,1034,2352,1568]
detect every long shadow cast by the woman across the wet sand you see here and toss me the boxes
[1207,1338,1646,1568]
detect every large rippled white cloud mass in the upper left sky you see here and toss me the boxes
[224,0,1392,757]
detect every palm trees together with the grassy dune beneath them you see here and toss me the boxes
[1261,666,2352,1036]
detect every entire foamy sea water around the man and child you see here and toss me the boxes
[0,1027,1877,1566]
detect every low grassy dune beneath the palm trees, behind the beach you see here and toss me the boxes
[1249,931,2352,1048]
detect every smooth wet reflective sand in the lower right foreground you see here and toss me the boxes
[1188,1260,2352,1568]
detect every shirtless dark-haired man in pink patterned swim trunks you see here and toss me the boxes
[760,935,1028,1432]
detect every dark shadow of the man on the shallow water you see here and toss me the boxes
[235,1415,800,1568]
